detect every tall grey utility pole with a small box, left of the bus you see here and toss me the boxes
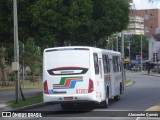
[12,0,19,103]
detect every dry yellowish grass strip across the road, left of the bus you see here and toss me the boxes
[0,80,42,91]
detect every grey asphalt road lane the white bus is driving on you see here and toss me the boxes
[24,72,160,111]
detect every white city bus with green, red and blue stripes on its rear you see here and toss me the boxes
[43,46,124,109]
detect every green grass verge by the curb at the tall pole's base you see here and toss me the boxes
[5,93,43,108]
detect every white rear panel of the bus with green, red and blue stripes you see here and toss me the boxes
[43,48,97,102]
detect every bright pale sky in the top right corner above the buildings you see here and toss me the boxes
[132,0,160,10]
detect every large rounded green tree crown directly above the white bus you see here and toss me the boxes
[31,0,129,46]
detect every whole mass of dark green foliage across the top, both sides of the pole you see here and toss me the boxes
[0,0,130,48]
